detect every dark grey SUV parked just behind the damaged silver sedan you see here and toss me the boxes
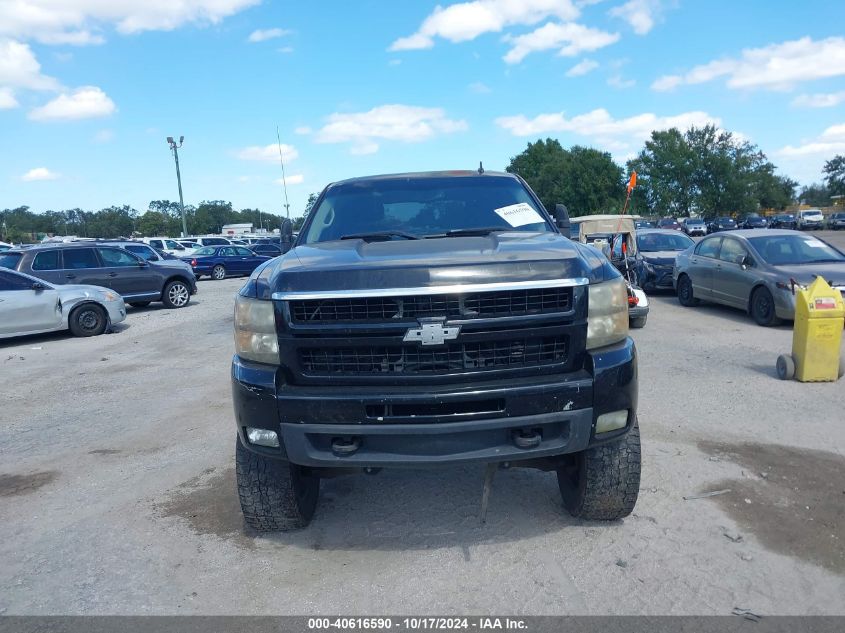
[0,242,197,308]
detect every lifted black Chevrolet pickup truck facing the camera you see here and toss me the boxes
[232,170,640,531]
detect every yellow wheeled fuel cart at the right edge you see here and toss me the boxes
[777,277,845,382]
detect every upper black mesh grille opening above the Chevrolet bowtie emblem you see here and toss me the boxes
[290,287,572,324]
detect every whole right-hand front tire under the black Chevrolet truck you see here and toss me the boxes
[557,418,641,521]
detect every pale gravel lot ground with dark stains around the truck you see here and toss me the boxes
[0,235,845,615]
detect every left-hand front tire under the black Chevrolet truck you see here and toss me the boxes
[235,438,320,532]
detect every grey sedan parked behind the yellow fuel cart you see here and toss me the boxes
[672,229,845,325]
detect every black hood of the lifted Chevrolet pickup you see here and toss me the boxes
[251,232,618,299]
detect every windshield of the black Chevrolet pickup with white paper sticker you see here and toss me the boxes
[303,175,553,244]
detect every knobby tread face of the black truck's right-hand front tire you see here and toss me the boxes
[561,421,642,521]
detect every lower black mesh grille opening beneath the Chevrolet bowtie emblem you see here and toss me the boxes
[299,336,567,376]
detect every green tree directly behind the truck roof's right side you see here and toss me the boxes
[507,139,625,216]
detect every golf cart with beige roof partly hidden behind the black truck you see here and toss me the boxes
[570,215,648,328]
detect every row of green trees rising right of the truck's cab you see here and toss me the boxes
[507,125,845,217]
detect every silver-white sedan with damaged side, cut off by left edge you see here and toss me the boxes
[0,268,126,339]
